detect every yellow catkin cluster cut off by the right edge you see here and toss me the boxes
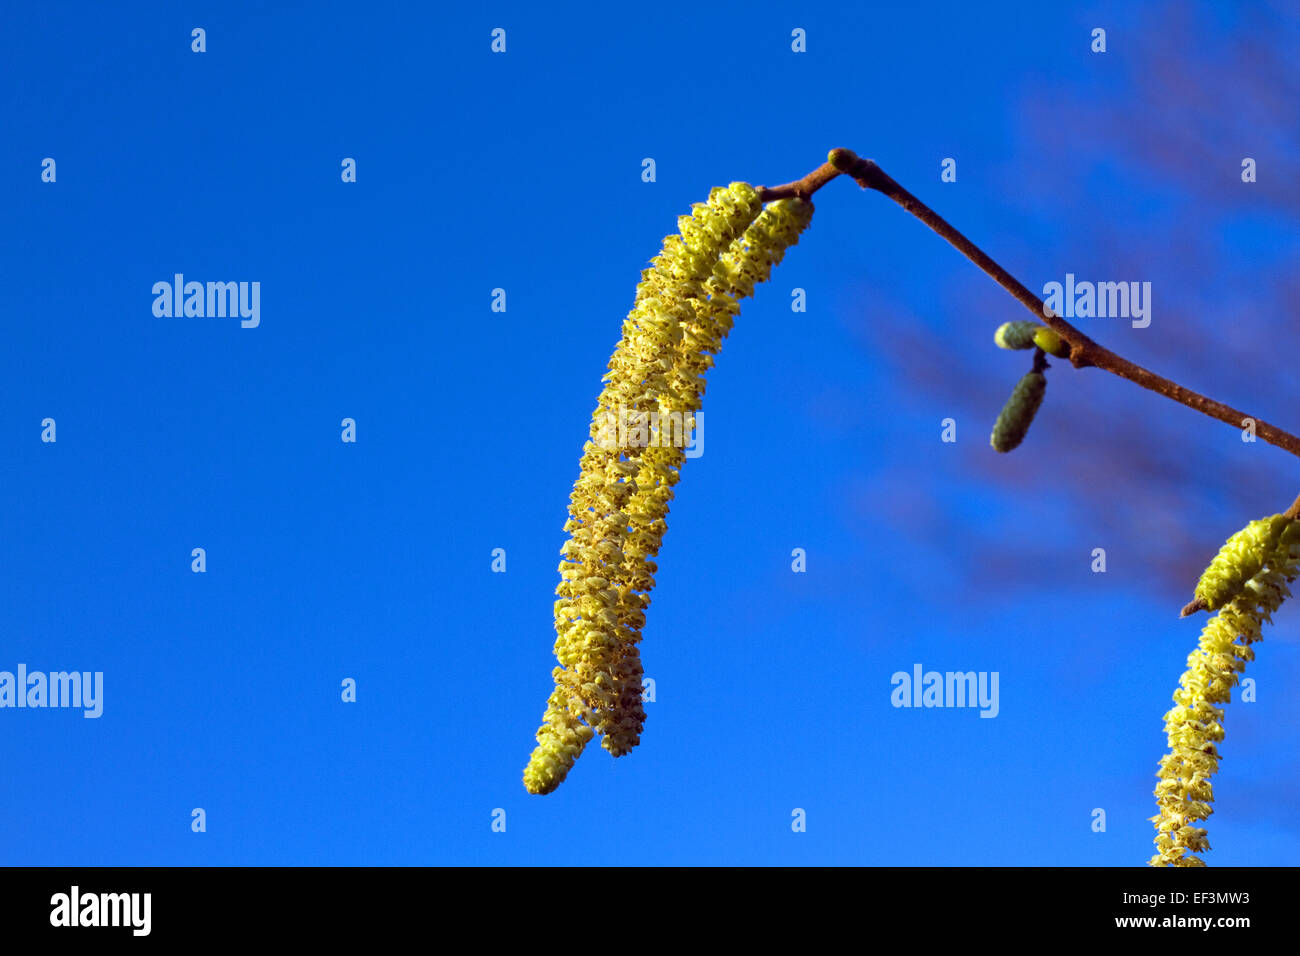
[1149,515,1300,866]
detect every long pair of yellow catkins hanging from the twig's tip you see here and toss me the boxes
[524,182,813,793]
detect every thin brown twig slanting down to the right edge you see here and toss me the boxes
[821,150,1300,463]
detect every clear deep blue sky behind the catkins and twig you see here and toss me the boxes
[0,3,1300,865]
